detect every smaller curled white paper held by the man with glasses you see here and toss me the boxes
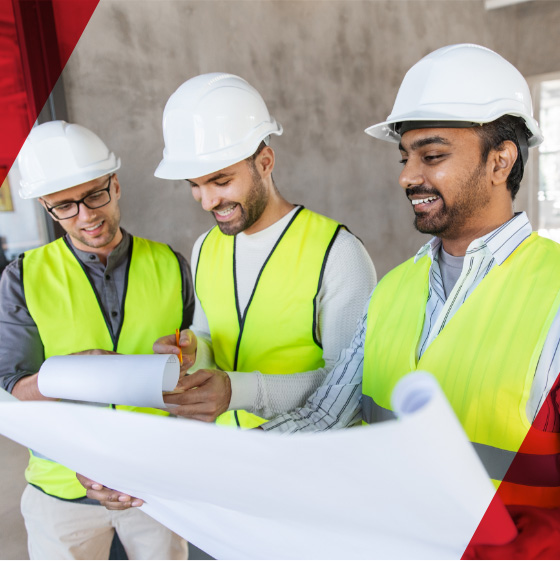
[38,354,180,409]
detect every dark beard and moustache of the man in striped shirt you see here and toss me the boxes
[406,164,490,238]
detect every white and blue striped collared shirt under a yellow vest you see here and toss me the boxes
[262,212,560,433]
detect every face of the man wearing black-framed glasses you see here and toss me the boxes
[39,175,122,255]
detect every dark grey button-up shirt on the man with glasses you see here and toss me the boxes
[0,229,194,392]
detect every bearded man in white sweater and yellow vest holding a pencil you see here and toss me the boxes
[154,73,376,428]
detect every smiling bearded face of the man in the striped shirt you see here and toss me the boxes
[399,128,499,244]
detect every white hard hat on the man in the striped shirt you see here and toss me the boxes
[365,44,543,146]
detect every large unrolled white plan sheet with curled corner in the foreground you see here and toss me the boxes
[0,374,500,559]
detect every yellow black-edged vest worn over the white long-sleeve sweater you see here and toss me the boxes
[195,208,341,428]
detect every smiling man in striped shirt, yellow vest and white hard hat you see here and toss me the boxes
[262,44,560,559]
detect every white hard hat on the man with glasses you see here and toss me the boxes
[18,121,121,199]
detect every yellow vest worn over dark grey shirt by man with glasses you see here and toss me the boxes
[22,234,183,499]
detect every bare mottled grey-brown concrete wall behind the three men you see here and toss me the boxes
[64,0,560,275]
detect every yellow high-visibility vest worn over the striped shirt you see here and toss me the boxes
[362,234,560,506]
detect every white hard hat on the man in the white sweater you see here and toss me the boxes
[154,72,282,179]
